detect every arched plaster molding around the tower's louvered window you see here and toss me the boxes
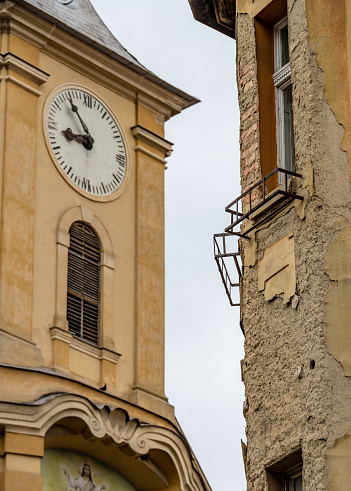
[55,206,115,350]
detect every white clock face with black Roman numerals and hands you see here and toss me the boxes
[44,86,129,201]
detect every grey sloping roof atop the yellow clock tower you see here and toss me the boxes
[13,0,198,106]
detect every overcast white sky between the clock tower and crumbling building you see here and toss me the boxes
[91,0,246,491]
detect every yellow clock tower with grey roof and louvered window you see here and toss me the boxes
[0,0,210,491]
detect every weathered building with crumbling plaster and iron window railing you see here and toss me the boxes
[189,0,351,491]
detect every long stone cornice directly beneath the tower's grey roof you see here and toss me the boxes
[6,5,199,119]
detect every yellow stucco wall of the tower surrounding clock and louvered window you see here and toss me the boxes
[0,1,182,420]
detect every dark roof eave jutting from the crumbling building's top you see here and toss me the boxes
[189,0,236,38]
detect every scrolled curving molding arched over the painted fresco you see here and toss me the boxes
[0,393,210,491]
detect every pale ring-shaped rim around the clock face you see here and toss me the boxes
[43,83,131,202]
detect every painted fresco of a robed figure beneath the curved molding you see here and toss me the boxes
[42,448,136,491]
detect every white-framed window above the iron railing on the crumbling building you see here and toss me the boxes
[273,17,295,178]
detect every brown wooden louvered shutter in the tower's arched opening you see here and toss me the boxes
[67,222,100,344]
